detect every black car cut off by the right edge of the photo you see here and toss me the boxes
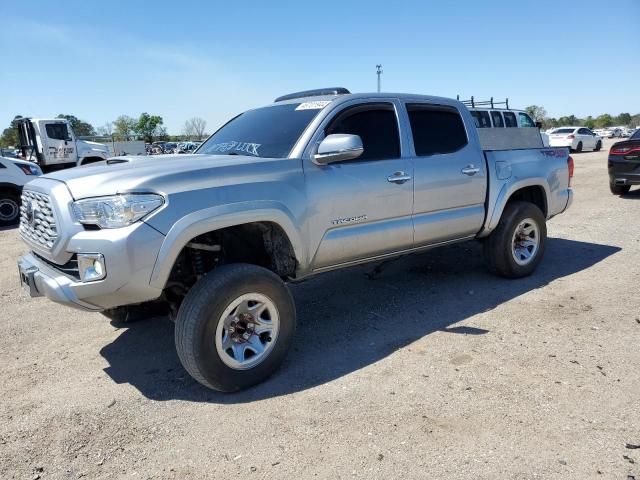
[608,130,640,195]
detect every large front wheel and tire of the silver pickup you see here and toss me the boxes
[175,264,296,392]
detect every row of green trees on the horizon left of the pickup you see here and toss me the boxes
[0,112,207,147]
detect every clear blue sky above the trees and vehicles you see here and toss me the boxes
[0,0,640,134]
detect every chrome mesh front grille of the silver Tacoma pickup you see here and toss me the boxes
[20,190,58,250]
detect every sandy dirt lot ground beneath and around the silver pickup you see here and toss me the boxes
[0,142,640,479]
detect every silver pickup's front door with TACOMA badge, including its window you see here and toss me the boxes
[304,101,413,270]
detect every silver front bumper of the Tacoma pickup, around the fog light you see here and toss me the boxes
[18,222,164,311]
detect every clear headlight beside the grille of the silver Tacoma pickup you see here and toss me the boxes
[73,193,164,228]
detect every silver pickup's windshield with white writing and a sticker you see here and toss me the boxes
[196,102,329,158]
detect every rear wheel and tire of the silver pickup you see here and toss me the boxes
[483,201,547,278]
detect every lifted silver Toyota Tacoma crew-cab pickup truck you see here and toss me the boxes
[18,89,573,392]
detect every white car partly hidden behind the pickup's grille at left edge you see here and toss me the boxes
[0,157,42,227]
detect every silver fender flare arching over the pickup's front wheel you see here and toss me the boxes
[149,201,307,289]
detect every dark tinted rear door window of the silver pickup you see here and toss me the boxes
[407,104,468,157]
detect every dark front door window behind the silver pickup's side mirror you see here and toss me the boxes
[325,103,400,161]
